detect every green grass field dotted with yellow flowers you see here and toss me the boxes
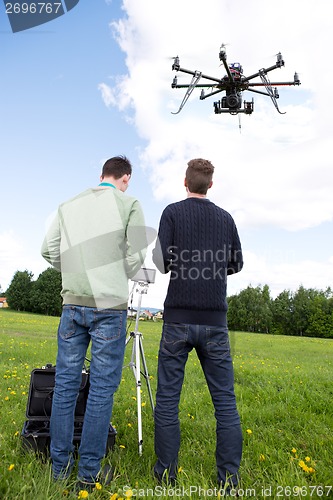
[0,310,333,500]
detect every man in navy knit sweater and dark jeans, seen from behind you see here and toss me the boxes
[153,158,243,490]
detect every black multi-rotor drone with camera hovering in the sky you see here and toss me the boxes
[171,44,301,115]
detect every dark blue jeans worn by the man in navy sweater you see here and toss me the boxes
[154,323,242,486]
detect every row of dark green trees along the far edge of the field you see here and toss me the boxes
[6,267,333,338]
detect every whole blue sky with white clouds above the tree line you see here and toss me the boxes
[0,0,333,307]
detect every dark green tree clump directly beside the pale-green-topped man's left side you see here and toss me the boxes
[31,267,62,316]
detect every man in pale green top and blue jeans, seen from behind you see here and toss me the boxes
[41,156,147,489]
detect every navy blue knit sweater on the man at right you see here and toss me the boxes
[153,198,243,325]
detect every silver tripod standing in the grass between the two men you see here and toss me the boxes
[124,281,154,455]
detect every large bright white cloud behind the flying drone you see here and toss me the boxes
[104,0,333,230]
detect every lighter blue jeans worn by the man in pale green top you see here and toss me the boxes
[50,305,127,482]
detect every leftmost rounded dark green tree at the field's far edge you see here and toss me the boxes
[6,270,33,311]
